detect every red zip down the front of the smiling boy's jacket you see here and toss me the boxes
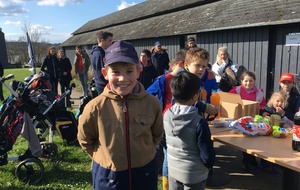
[122,97,132,190]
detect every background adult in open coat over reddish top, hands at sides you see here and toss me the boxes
[74,46,91,96]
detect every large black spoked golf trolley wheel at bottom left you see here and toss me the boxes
[15,158,45,184]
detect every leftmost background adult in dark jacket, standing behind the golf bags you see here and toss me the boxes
[41,46,60,93]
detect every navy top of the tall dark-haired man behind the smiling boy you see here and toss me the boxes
[91,45,107,89]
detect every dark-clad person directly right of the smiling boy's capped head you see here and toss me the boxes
[138,49,157,89]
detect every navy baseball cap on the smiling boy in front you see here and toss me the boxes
[104,41,139,66]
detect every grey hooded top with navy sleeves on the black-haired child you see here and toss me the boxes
[164,103,215,184]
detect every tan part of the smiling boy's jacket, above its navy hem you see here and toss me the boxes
[78,83,163,171]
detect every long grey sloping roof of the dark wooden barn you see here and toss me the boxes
[61,0,300,46]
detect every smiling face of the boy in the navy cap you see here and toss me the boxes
[102,63,140,96]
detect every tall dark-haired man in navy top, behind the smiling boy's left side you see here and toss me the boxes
[91,31,113,95]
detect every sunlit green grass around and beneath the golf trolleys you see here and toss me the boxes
[0,69,162,190]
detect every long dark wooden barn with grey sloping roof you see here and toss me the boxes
[61,0,300,97]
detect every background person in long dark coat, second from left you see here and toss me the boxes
[57,50,72,107]
